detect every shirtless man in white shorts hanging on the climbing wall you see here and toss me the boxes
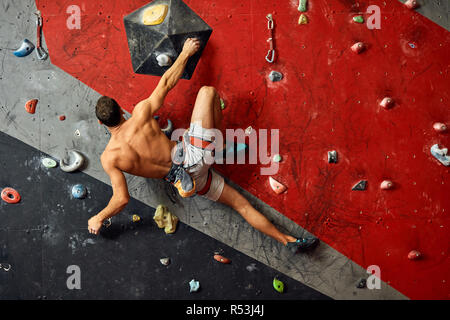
[88,39,318,253]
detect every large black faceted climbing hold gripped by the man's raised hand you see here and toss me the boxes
[124,0,212,79]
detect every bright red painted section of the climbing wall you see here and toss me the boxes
[32,0,450,298]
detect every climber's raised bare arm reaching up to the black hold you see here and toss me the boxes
[133,38,200,120]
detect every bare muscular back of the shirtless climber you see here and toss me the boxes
[101,102,176,178]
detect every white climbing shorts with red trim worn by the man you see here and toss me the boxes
[183,123,225,201]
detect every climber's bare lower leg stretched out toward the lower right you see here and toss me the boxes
[218,183,297,245]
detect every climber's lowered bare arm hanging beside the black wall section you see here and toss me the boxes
[88,161,130,234]
